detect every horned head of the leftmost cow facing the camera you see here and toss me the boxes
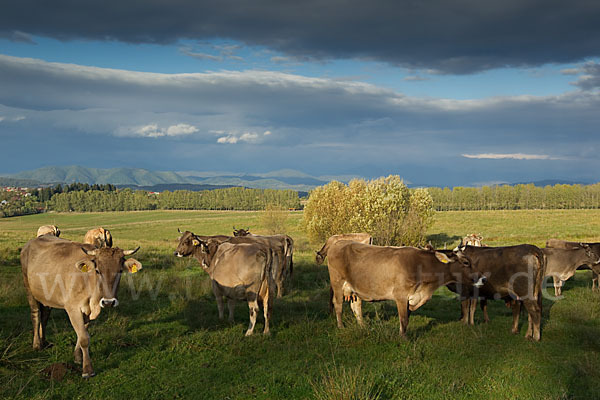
[75,246,142,307]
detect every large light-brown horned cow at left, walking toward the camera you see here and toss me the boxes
[21,235,142,378]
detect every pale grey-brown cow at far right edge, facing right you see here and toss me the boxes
[542,243,600,297]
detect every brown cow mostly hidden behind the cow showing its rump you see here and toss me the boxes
[230,227,294,297]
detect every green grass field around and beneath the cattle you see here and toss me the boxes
[0,210,600,399]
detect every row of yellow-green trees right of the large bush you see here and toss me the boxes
[428,183,600,211]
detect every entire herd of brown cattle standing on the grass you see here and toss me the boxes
[21,225,600,378]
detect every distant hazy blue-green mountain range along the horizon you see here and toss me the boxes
[0,165,594,192]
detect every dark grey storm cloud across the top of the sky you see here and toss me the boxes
[0,0,600,74]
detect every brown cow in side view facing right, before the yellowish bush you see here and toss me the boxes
[327,240,485,336]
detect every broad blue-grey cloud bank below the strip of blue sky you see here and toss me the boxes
[0,55,600,184]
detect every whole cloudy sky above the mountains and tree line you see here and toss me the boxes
[0,0,600,186]
